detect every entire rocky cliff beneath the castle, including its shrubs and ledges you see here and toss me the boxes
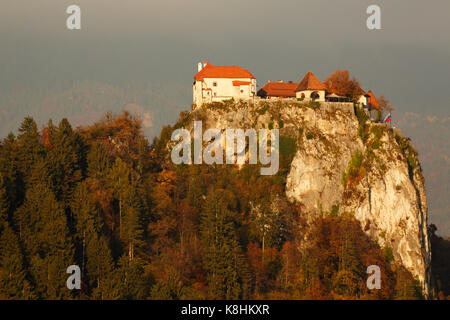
[186,101,431,294]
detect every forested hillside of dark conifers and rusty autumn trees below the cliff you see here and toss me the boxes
[0,112,450,299]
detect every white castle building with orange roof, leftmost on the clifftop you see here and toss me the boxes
[192,62,256,106]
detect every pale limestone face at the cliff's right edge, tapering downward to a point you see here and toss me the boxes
[347,130,431,294]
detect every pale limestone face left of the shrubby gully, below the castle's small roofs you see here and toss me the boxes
[286,104,363,214]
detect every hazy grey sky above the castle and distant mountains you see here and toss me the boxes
[0,0,450,115]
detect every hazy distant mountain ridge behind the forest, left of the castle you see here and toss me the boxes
[0,80,190,138]
